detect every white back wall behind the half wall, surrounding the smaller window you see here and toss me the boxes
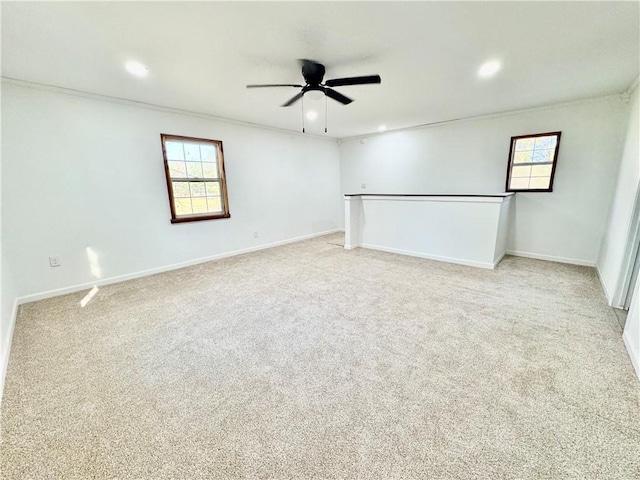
[340,96,627,265]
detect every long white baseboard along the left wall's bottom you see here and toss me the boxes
[17,228,341,305]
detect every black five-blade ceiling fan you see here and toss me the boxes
[247,59,381,107]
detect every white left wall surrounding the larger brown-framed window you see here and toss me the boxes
[2,82,342,296]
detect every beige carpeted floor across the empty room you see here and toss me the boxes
[0,235,640,480]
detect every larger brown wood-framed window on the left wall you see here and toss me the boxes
[160,134,230,223]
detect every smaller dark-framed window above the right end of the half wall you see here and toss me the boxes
[507,132,560,192]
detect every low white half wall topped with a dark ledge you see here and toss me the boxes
[345,195,513,269]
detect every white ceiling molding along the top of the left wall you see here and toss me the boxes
[0,75,338,143]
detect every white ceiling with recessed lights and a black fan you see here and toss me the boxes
[2,2,640,138]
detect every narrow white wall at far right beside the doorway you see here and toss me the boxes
[598,88,640,306]
